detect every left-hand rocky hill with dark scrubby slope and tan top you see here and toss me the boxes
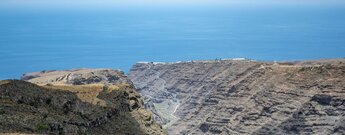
[0,69,165,135]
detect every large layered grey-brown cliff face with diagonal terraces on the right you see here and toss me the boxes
[129,59,345,134]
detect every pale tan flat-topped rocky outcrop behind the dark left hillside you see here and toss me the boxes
[21,69,130,85]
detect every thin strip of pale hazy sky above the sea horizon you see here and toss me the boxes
[0,0,345,8]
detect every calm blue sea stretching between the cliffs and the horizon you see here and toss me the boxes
[0,7,345,79]
